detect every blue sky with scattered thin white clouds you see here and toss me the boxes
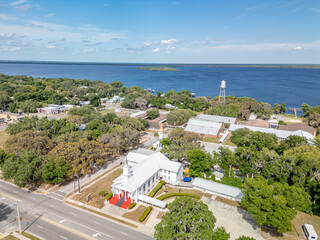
[0,0,320,64]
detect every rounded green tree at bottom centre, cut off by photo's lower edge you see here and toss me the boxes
[154,197,220,240]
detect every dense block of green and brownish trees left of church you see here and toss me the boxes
[0,106,145,187]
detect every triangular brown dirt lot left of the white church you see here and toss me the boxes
[72,168,122,208]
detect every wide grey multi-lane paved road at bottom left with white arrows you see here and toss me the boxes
[0,181,152,240]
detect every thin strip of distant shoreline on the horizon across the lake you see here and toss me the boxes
[0,60,320,69]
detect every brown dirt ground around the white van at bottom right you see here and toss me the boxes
[261,212,320,240]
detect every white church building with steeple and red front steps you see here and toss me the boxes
[112,150,183,202]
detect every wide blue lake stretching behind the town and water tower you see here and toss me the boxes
[0,63,320,107]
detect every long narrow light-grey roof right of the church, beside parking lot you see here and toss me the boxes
[192,178,243,201]
